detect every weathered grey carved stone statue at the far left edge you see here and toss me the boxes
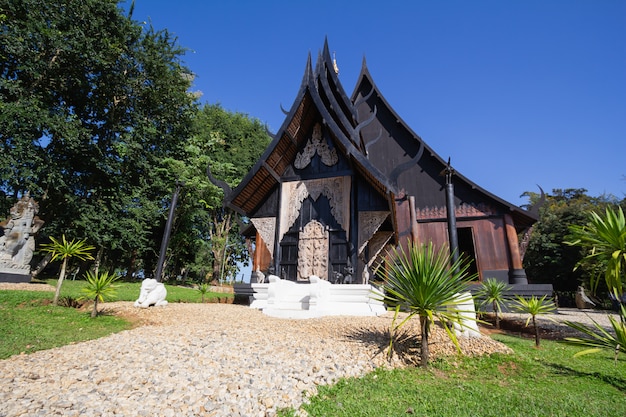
[0,194,44,275]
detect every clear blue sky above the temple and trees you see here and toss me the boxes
[126,0,626,205]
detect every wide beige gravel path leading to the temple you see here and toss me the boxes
[0,287,616,416]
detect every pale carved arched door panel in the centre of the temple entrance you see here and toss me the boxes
[298,220,329,280]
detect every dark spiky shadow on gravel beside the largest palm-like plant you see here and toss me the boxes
[346,328,421,366]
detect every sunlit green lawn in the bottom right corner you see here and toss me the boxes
[281,335,626,417]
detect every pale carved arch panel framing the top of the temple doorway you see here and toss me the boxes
[280,177,350,240]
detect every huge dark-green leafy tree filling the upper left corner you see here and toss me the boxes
[0,0,196,272]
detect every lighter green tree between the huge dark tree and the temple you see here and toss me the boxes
[162,104,270,281]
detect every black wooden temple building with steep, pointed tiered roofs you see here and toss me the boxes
[226,43,537,287]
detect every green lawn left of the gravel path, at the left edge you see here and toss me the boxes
[0,291,131,359]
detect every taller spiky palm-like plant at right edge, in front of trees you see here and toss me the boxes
[565,207,626,294]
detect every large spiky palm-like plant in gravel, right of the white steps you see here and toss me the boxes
[376,242,474,366]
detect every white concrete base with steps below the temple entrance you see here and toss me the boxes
[250,275,387,319]
